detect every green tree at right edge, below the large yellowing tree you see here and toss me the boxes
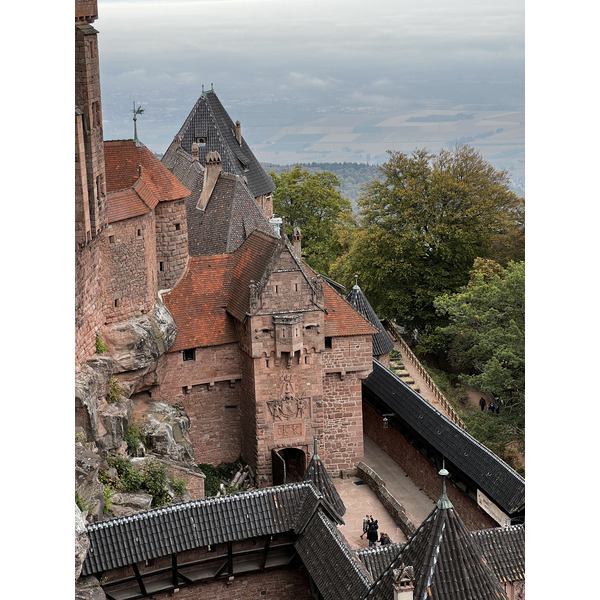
[434,262,525,418]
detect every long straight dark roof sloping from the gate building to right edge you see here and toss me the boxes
[363,360,525,515]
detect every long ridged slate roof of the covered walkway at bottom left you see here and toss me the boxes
[81,483,311,576]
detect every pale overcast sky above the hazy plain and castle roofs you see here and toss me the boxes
[94,0,524,152]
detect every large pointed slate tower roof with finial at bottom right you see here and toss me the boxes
[366,469,508,600]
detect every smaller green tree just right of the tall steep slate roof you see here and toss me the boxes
[271,165,352,275]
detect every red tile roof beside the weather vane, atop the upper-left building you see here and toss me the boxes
[104,140,190,199]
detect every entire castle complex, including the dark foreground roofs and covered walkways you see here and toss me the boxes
[75,0,524,600]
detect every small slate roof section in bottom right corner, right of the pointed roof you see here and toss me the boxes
[471,525,525,583]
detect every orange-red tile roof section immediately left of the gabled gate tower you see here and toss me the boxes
[163,254,237,352]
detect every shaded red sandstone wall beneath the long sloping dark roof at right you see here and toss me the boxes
[363,404,498,531]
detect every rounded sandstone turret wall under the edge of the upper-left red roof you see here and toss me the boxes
[155,200,188,290]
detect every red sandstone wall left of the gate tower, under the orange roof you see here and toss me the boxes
[152,344,242,465]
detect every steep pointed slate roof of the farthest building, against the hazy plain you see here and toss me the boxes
[163,90,275,198]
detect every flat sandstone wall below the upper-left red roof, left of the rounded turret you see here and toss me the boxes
[103,213,157,323]
